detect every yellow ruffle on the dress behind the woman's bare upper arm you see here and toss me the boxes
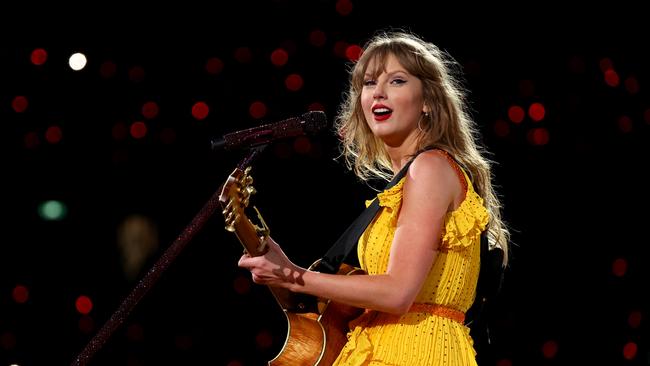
[442,189,490,249]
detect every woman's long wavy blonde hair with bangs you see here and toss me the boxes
[335,32,510,265]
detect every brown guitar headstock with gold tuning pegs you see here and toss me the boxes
[219,167,270,256]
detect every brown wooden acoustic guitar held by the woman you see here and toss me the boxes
[219,166,364,366]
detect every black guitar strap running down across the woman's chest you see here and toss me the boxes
[317,159,413,274]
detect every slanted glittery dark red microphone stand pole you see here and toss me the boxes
[71,145,267,366]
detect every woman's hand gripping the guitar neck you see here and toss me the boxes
[238,237,305,289]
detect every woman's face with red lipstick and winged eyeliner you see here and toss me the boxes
[361,54,425,147]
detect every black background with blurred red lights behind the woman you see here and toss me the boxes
[0,1,650,366]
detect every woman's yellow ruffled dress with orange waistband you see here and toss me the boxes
[334,163,488,366]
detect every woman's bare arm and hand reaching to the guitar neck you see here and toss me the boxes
[239,152,463,314]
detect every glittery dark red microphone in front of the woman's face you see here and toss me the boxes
[210,111,327,150]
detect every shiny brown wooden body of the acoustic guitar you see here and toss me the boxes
[269,264,364,366]
